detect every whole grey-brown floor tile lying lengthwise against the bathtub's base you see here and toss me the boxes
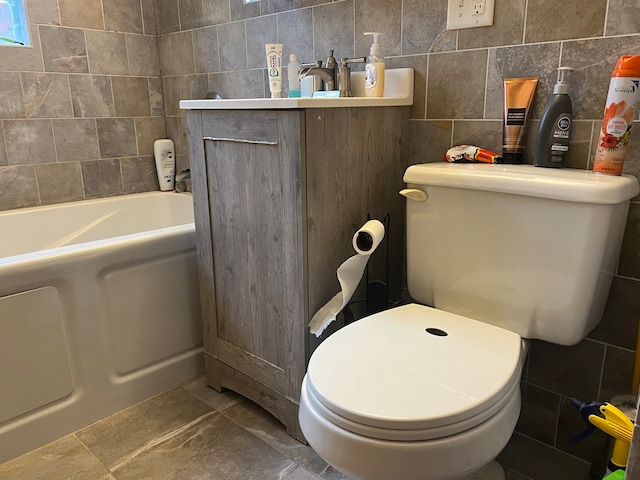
[76,387,214,469]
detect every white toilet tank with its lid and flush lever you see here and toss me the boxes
[403,163,639,345]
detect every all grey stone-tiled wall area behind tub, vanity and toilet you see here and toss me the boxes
[0,0,640,480]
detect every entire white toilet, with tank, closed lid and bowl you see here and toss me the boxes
[299,163,639,480]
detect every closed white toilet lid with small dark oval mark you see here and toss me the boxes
[306,304,522,438]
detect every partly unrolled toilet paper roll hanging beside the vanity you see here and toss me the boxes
[309,220,384,337]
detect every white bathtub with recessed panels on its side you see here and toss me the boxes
[0,192,204,463]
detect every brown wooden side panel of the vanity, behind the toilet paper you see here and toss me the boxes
[306,107,408,336]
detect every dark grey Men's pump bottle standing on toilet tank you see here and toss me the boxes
[533,67,573,168]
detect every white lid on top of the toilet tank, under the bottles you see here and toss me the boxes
[404,163,640,204]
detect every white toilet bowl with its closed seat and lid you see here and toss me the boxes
[299,304,525,480]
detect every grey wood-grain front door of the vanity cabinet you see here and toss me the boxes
[203,112,304,388]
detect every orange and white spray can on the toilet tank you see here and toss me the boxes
[593,55,640,175]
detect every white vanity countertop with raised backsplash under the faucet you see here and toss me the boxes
[180,68,413,110]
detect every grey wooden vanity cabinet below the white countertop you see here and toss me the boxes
[187,107,409,441]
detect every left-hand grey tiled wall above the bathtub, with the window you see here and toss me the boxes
[0,0,166,210]
